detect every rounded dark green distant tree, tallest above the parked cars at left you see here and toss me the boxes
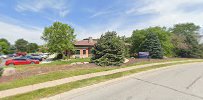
[15,39,28,52]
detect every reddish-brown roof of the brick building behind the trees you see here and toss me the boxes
[75,40,96,46]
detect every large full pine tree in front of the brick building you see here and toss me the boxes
[92,32,124,66]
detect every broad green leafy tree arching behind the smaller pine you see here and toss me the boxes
[131,27,174,56]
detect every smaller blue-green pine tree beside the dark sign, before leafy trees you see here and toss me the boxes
[140,33,163,59]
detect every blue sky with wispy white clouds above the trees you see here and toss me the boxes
[0,0,203,44]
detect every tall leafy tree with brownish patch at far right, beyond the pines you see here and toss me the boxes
[171,23,202,57]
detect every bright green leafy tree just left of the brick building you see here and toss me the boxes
[42,22,76,55]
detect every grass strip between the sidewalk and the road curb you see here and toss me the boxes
[2,61,202,100]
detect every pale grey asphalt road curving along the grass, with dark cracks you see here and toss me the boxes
[48,63,203,100]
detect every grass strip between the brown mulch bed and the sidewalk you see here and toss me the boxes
[0,59,198,91]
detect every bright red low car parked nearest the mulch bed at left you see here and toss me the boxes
[5,58,39,66]
